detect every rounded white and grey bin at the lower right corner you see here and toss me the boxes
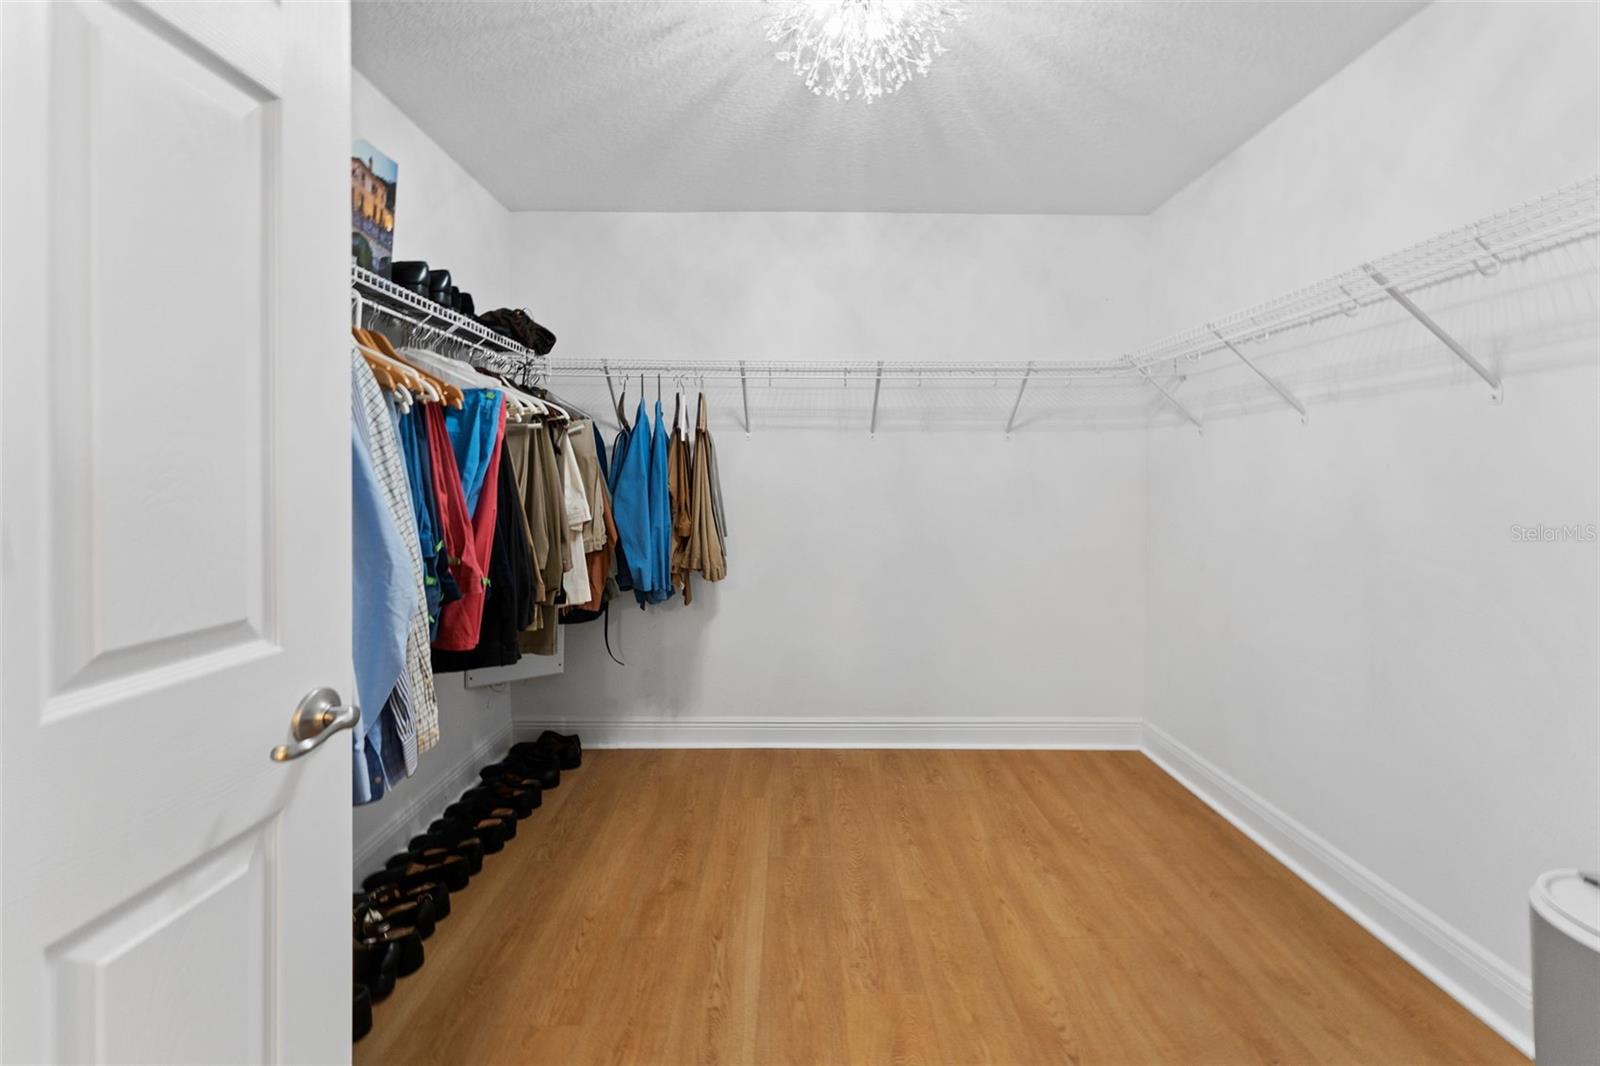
[1528,869,1600,1066]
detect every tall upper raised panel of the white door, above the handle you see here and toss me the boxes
[46,5,282,714]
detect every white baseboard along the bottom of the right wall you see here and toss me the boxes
[1144,722,1533,1056]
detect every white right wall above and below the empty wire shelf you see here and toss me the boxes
[1147,5,1600,1029]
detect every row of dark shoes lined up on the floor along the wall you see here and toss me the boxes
[352,730,584,1040]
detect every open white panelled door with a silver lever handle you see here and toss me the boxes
[0,0,354,1063]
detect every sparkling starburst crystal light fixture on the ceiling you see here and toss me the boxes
[766,0,966,102]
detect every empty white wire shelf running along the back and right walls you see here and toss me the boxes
[549,176,1600,432]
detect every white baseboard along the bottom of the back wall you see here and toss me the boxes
[512,717,1139,749]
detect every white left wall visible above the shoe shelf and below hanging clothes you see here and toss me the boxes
[350,70,512,877]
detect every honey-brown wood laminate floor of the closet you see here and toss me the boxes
[355,751,1526,1066]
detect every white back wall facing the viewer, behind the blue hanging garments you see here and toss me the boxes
[512,213,1146,738]
